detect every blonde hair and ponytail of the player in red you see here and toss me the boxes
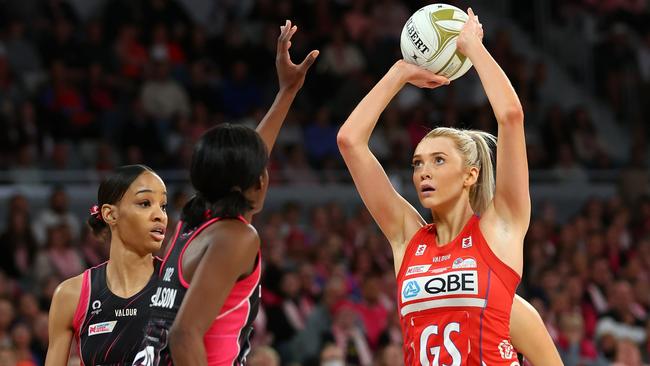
[424,127,497,213]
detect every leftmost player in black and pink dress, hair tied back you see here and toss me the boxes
[45,165,167,366]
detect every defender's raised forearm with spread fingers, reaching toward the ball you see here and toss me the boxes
[257,20,318,154]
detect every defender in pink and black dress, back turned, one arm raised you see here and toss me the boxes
[133,21,318,366]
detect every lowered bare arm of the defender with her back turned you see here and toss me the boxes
[169,220,260,366]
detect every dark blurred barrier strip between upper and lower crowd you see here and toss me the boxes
[0,170,650,228]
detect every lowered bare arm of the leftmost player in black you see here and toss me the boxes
[45,275,83,366]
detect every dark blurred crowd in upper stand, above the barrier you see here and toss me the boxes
[0,0,650,183]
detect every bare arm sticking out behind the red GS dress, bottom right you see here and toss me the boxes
[510,295,563,366]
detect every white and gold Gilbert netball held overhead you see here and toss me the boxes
[400,4,472,80]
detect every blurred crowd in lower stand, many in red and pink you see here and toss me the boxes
[0,188,650,366]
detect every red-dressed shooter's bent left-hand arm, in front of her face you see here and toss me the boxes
[337,60,449,258]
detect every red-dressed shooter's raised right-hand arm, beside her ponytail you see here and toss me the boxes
[457,8,530,234]
